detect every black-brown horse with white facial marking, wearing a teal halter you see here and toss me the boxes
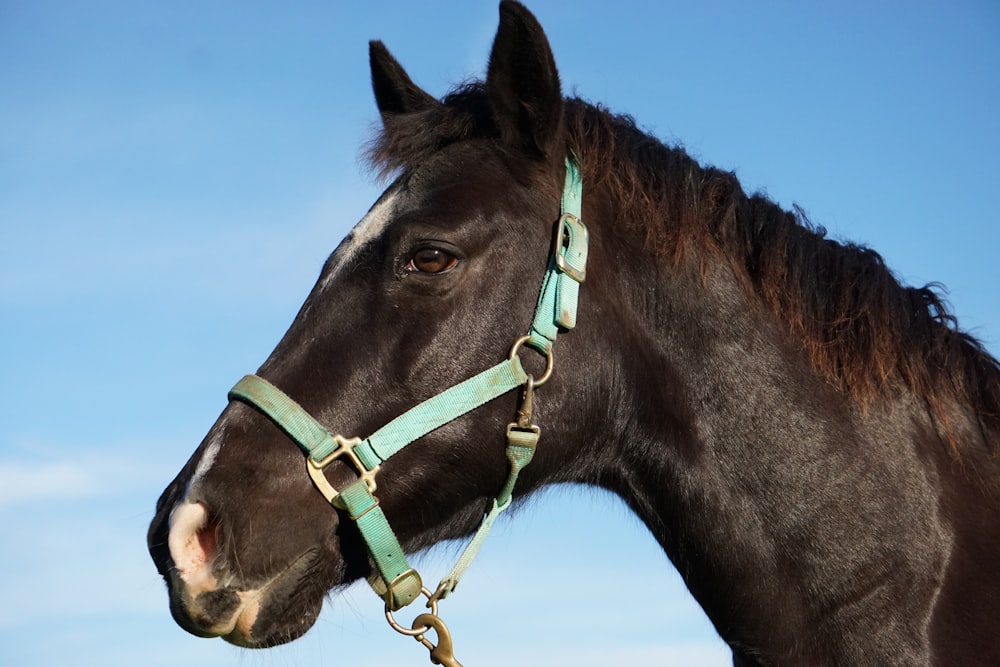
[147,1,1000,665]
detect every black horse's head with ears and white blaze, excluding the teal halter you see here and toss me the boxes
[148,3,612,646]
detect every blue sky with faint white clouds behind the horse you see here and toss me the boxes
[0,0,1000,667]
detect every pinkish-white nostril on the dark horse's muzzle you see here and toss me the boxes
[167,502,217,594]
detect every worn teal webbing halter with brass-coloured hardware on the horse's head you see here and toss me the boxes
[229,156,588,667]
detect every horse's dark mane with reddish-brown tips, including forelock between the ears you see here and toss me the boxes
[367,82,1000,448]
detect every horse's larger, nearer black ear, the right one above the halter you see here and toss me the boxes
[486,1,563,156]
